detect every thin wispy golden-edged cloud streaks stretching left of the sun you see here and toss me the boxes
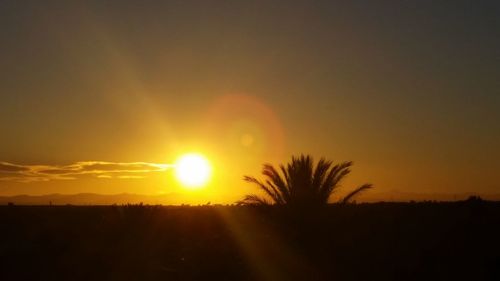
[0,161,173,182]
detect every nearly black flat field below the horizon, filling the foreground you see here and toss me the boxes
[0,201,500,280]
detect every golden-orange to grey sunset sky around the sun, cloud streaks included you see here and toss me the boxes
[0,0,500,202]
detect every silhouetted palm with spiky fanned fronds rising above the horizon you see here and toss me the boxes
[237,155,373,206]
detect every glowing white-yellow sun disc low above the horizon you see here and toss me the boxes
[175,153,212,189]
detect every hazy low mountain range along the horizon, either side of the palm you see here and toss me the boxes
[0,191,500,205]
